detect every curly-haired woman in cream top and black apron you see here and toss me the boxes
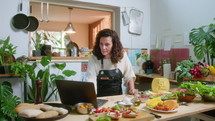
[87,29,136,96]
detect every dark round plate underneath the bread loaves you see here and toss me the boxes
[20,103,72,121]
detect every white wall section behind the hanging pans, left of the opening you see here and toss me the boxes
[0,0,29,57]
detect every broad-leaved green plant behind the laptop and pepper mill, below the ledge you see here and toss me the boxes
[12,55,76,102]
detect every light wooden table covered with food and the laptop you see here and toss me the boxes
[55,95,215,121]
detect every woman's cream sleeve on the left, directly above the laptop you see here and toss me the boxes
[86,55,97,91]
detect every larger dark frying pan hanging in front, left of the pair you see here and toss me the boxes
[12,3,29,29]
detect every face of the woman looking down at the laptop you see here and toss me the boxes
[99,37,113,59]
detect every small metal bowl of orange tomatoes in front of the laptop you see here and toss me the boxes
[75,102,94,114]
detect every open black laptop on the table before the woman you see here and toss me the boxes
[56,80,108,108]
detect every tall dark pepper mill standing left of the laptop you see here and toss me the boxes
[35,80,43,104]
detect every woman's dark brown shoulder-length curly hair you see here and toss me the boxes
[93,29,123,64]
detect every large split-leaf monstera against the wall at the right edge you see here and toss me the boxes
[189,18,215,65]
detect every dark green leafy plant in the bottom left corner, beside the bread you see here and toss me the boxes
[0,81,21,121]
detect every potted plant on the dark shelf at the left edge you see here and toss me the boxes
[0,36,17,74]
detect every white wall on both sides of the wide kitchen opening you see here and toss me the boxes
[0,0,150,57]
